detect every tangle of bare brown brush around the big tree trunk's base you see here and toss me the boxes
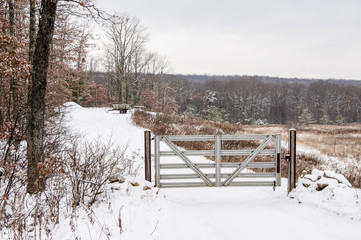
[0,125,135,239]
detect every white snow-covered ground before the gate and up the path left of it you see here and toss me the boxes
[52,104,361,240]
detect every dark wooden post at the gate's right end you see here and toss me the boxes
[288,129,297,193]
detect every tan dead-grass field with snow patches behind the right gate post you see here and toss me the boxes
[242,123,361,188]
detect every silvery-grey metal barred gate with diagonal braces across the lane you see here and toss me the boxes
[154,134,281,188]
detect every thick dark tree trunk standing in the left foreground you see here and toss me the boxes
[27,0,58,194]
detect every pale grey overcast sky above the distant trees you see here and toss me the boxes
[93,0,361,80]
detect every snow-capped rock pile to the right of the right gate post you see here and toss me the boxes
[289,169,361,220]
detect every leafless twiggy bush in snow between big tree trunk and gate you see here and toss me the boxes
[63,137,132,207]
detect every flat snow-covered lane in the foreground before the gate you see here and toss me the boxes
[155,187,361,240]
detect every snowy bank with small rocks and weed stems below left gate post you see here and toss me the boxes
[52,176,164,240]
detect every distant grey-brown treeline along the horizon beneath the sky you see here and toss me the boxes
[167,75,361,125]
